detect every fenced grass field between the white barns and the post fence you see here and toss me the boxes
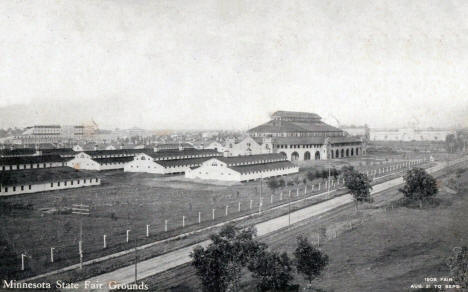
[0,153,430,279]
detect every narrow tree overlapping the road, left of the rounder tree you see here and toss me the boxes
[343,168,372,212]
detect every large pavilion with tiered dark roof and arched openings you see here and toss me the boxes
[248,111,365,161]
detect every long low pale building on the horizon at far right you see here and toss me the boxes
[370,128,455,142]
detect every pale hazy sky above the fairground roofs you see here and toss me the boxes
[0,0,468,129]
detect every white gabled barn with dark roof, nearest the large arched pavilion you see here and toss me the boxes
[185,154,299,182]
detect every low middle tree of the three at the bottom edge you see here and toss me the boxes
[249,250,294,291]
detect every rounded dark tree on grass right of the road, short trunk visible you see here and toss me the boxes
[399,167,438,208]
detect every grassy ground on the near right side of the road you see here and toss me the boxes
[146,160,468,292]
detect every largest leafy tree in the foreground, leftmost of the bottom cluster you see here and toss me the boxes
[190,224,267,292]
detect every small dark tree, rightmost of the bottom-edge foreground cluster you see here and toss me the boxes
[294,235,328,285]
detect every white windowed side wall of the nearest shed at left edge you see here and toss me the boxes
[0,178,101,196]
